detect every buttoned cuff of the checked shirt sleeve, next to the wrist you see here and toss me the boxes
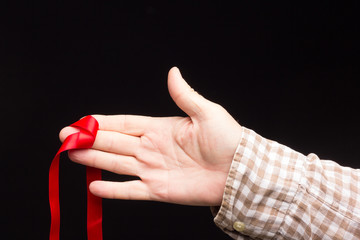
[211,127,306,239]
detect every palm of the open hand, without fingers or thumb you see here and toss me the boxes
[138,109,238,205]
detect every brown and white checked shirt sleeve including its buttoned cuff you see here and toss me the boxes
[212,127,360,240]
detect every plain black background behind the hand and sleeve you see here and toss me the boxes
[0,1,360,240]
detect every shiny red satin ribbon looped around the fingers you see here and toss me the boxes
[49,116,102,240]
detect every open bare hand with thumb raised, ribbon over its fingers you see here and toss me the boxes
[60,68,241,206]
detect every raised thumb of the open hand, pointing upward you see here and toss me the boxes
[168,67,209,117]
